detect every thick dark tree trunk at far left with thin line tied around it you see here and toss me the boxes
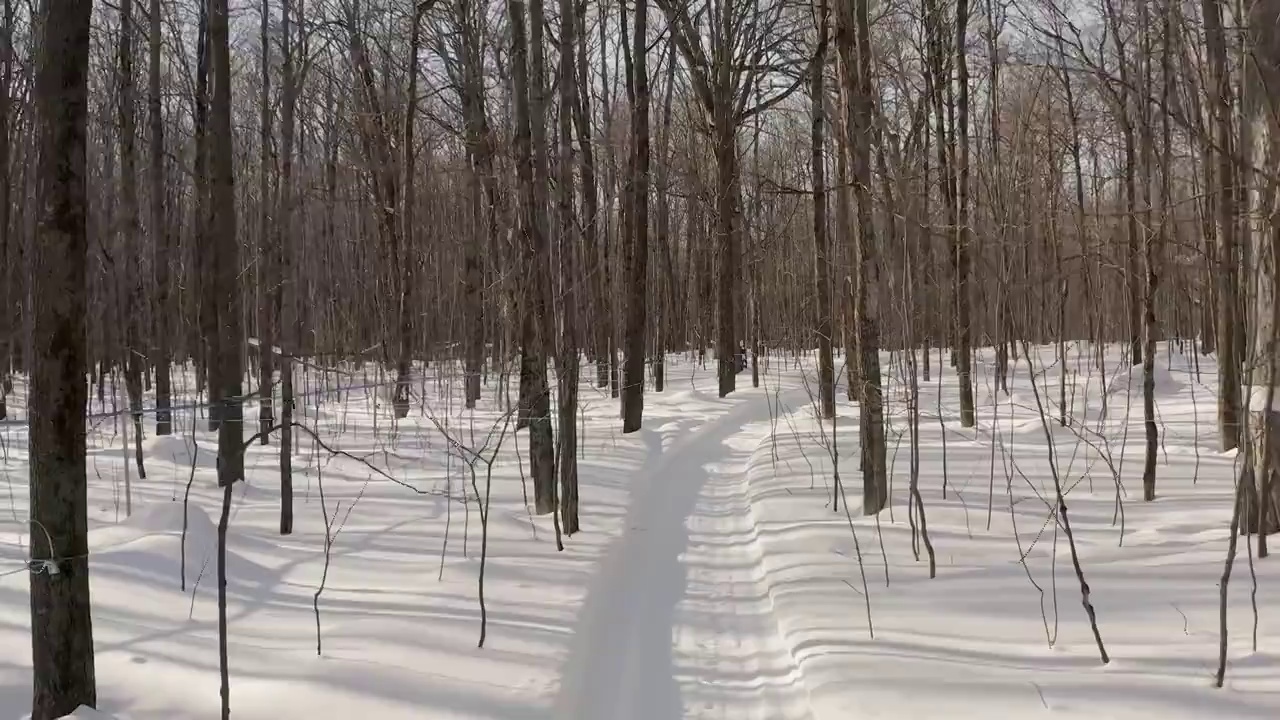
[28,0,97,720]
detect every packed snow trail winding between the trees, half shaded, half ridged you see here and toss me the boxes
[554,391,813,720]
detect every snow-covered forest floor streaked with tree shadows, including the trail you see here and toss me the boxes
[0,346,1280,720]
